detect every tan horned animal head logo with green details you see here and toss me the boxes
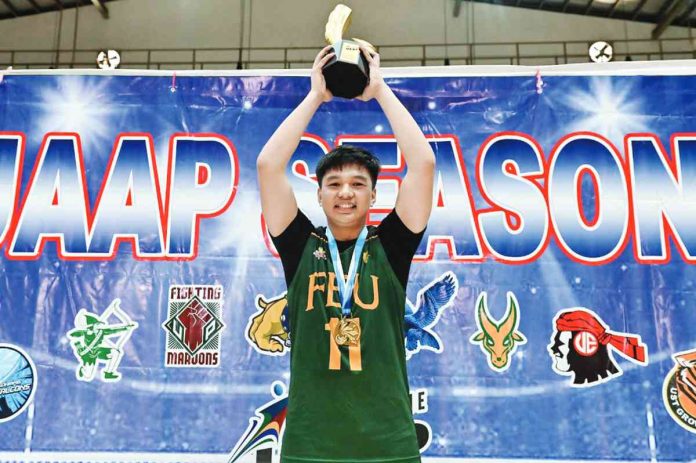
[470,292,527,373]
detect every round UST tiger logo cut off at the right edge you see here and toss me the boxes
[662,349,696,434]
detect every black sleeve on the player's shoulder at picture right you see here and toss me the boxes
[377,209,425,288]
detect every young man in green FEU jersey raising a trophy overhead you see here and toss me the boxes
[257,47,435,463]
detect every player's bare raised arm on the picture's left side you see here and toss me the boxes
[256,46,333,236]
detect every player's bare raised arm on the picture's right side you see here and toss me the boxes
[358,46,435,233]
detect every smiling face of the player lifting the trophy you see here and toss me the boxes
[317,164,376,232]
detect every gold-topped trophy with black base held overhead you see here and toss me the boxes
[322,4,374,98]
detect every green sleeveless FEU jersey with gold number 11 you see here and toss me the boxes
[281,227,420,463]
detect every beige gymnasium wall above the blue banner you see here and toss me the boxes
[0,0,693,68]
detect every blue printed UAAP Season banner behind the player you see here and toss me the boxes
[0,62,696,462]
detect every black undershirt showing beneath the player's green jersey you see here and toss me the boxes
[271,209,425,289]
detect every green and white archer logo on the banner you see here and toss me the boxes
[67,299,138,382]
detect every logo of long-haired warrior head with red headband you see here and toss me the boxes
[548,308,648,387]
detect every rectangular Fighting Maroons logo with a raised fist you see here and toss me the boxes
[162,285,225,367]
